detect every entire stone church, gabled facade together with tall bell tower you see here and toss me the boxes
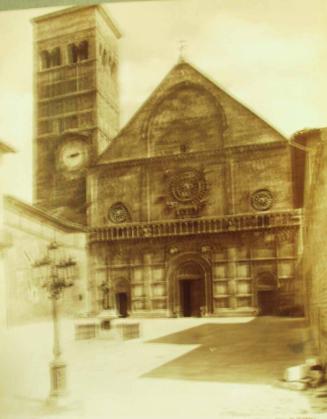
[30,6,303,317]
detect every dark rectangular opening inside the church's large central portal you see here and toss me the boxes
[179,279,204,317]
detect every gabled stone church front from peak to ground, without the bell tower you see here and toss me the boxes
[87,61,303,317]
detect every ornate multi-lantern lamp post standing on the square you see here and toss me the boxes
[33,241,76,404]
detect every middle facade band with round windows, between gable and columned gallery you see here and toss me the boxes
[89,144,293,230]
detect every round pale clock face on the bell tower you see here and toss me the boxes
[58,138,89,174]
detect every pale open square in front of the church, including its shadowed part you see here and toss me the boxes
[0,317,327,419]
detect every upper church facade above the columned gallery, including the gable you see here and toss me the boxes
[88,63,294,227]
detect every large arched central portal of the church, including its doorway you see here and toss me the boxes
[168,254,212,317]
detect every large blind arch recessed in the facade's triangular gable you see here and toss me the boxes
[143,81,227,156]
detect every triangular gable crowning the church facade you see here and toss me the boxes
[98,62,287,164]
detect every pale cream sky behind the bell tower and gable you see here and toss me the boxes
[0,0,327,201]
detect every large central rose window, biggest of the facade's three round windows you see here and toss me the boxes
[170,169,206,202]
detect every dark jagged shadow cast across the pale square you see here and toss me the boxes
[143,317,306,384]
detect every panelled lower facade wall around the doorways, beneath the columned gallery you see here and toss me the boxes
[90,229,303,316]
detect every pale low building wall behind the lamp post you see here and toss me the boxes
[4,197,88,324]
